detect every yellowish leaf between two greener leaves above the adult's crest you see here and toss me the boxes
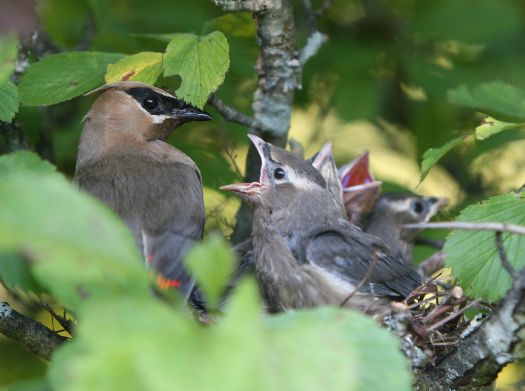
[106,52,162,84]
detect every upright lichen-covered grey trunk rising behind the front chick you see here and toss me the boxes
[228,0,301,243]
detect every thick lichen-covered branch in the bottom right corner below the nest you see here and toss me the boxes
[416,270,525,390]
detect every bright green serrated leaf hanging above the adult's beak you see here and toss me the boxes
[164,31,230,108]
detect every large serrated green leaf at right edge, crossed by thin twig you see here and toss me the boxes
[444,192,525,301]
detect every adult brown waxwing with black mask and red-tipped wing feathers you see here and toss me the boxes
[74,82,211,298]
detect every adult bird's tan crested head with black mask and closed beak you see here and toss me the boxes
[79,81,212,161]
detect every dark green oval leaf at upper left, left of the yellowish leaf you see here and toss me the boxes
[19,52,123,106]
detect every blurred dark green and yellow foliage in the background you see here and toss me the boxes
[0,0,525,384]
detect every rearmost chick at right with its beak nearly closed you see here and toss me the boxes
[365,193,448,265]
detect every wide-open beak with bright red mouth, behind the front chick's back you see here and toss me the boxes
[339,151,382,226]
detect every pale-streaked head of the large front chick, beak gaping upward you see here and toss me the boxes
[221,135,340,225]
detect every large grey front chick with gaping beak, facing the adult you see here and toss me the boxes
[222,135,420,314]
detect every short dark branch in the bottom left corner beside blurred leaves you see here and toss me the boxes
[0,302,68,360]
